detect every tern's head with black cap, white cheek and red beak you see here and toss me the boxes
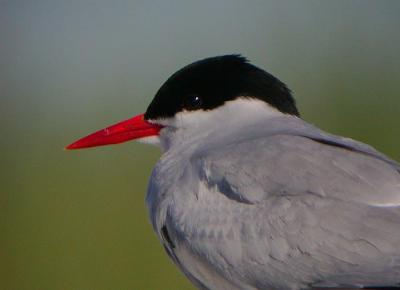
[66,55,299,150]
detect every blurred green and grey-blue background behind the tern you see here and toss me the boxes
[0,0,400,290]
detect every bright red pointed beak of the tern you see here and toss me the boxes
[65,114,162,149]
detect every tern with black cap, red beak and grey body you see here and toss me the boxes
[66,54,400,290]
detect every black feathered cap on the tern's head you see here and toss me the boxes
[145,55,299,119]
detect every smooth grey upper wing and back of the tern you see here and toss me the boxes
[192,118,400,205]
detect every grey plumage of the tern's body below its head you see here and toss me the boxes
[147,111,400,290]
